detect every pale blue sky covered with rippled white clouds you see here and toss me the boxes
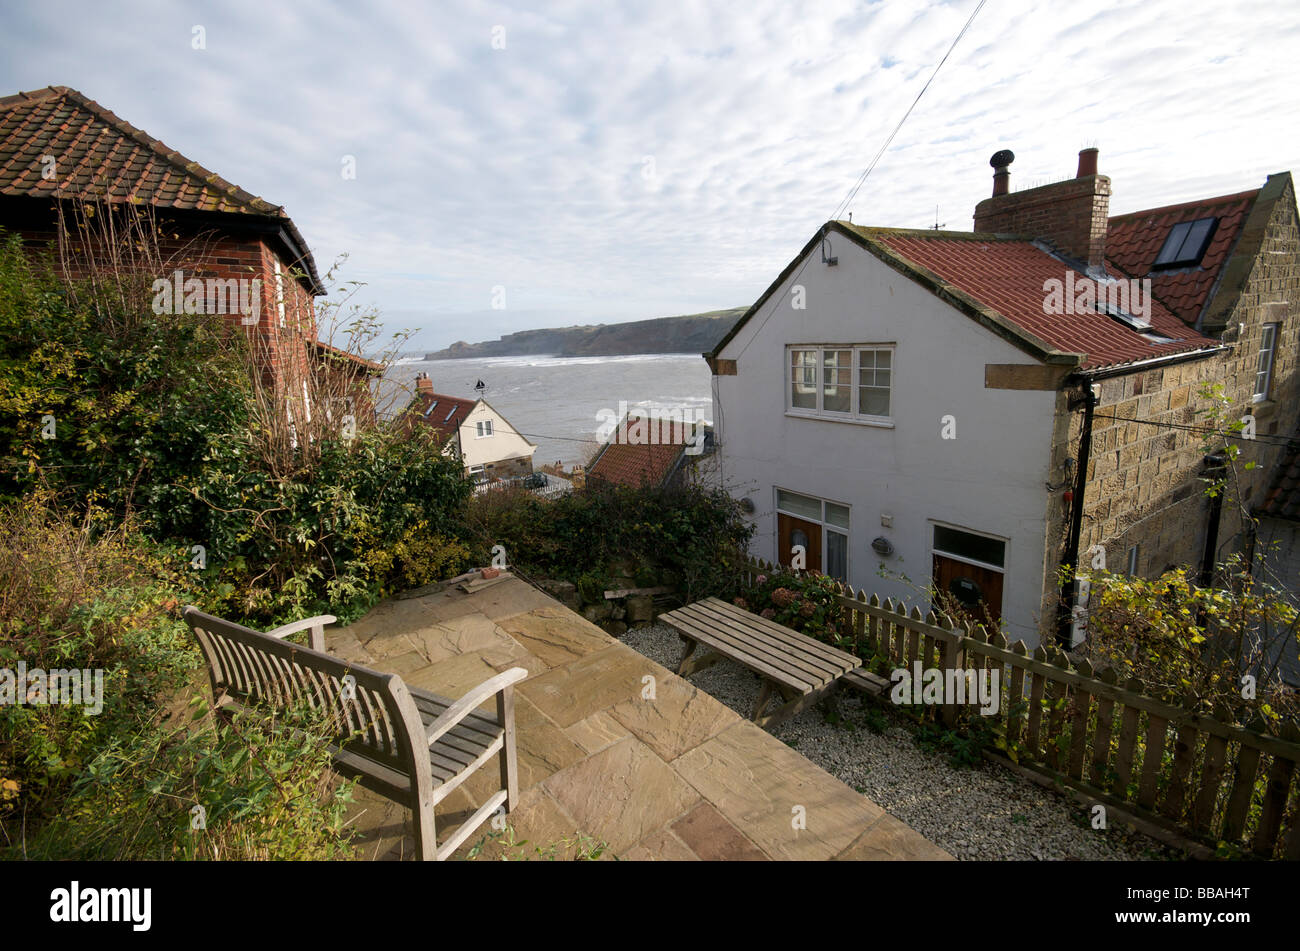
[0,0,1300,348]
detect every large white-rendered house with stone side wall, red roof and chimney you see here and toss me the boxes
[705,149,1300,646]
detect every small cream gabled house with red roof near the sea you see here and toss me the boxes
[411,373,537,482]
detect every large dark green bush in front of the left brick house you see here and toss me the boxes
[0,234,471,624]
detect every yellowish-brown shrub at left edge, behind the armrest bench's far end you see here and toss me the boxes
[0,494,198,820]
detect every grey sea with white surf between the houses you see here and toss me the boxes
[382,353,712,468]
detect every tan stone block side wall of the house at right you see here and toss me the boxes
[1041,179,1300,634]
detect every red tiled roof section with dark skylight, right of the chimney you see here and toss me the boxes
[1106,188,1260,325]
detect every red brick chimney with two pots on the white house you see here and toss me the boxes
[975,148,1110,268]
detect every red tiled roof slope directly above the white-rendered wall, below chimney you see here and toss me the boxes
[857,222,1219,369]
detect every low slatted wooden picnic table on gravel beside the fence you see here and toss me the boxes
[659,598,861,729]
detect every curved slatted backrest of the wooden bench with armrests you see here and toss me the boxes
[185,607,429,780]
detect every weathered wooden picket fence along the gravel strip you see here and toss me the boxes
[745,561,1300,860]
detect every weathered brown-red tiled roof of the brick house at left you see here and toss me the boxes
[0,86,320,288]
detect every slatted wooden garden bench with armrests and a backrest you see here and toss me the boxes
[185,607,528,861]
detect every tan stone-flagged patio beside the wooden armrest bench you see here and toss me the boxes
[325,576,952,860]
